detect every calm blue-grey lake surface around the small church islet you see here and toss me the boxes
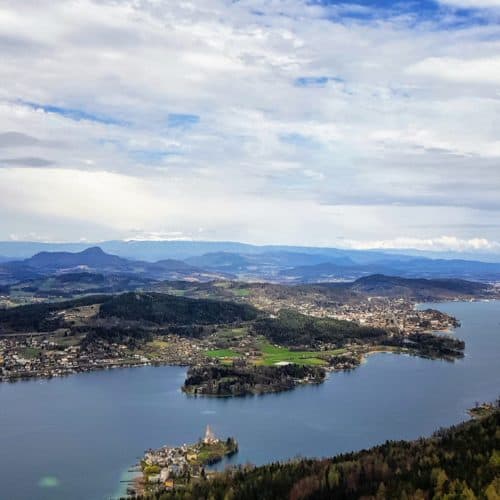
[0,302,500,500]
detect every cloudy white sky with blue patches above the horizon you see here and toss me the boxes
[0,0,500,254]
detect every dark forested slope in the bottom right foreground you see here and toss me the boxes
[138,410,500,500]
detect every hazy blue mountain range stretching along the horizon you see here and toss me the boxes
[0,241,500,284]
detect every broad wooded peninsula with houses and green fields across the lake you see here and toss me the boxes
[0,278,465,390]
